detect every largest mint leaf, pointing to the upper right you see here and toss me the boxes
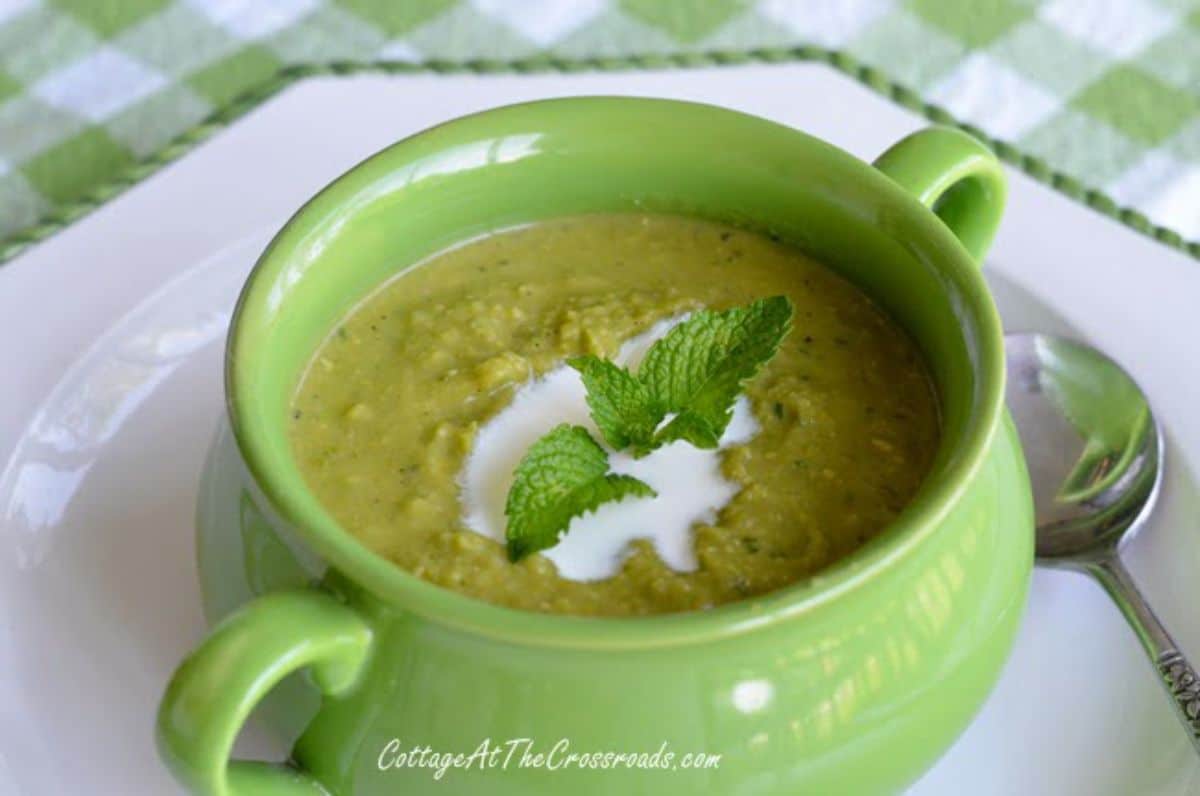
[637,295,792,448]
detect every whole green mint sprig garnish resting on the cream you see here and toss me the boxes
[504,295,792,562]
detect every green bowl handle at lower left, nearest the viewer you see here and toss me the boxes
[157,589,372,796]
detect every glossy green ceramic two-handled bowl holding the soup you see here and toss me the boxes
[158,98,1032,796]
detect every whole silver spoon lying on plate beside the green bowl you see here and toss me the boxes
[1004,334,1200,752]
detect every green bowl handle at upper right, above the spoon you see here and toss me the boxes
[875,127,1007,263]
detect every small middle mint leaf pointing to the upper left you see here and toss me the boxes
[566,354,664,450]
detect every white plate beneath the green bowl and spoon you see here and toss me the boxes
[0,65,1200,795]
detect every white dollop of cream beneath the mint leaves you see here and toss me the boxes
[458,316,758,581]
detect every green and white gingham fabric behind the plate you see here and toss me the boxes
[0,0,1200,253]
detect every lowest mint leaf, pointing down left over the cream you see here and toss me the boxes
[504,423,656,562]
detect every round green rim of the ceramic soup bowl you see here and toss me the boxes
[224,96,1004,650]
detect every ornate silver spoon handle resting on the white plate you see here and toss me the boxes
[1088,556,1200,752]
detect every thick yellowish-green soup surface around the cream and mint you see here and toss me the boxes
[290,214,938,615]
